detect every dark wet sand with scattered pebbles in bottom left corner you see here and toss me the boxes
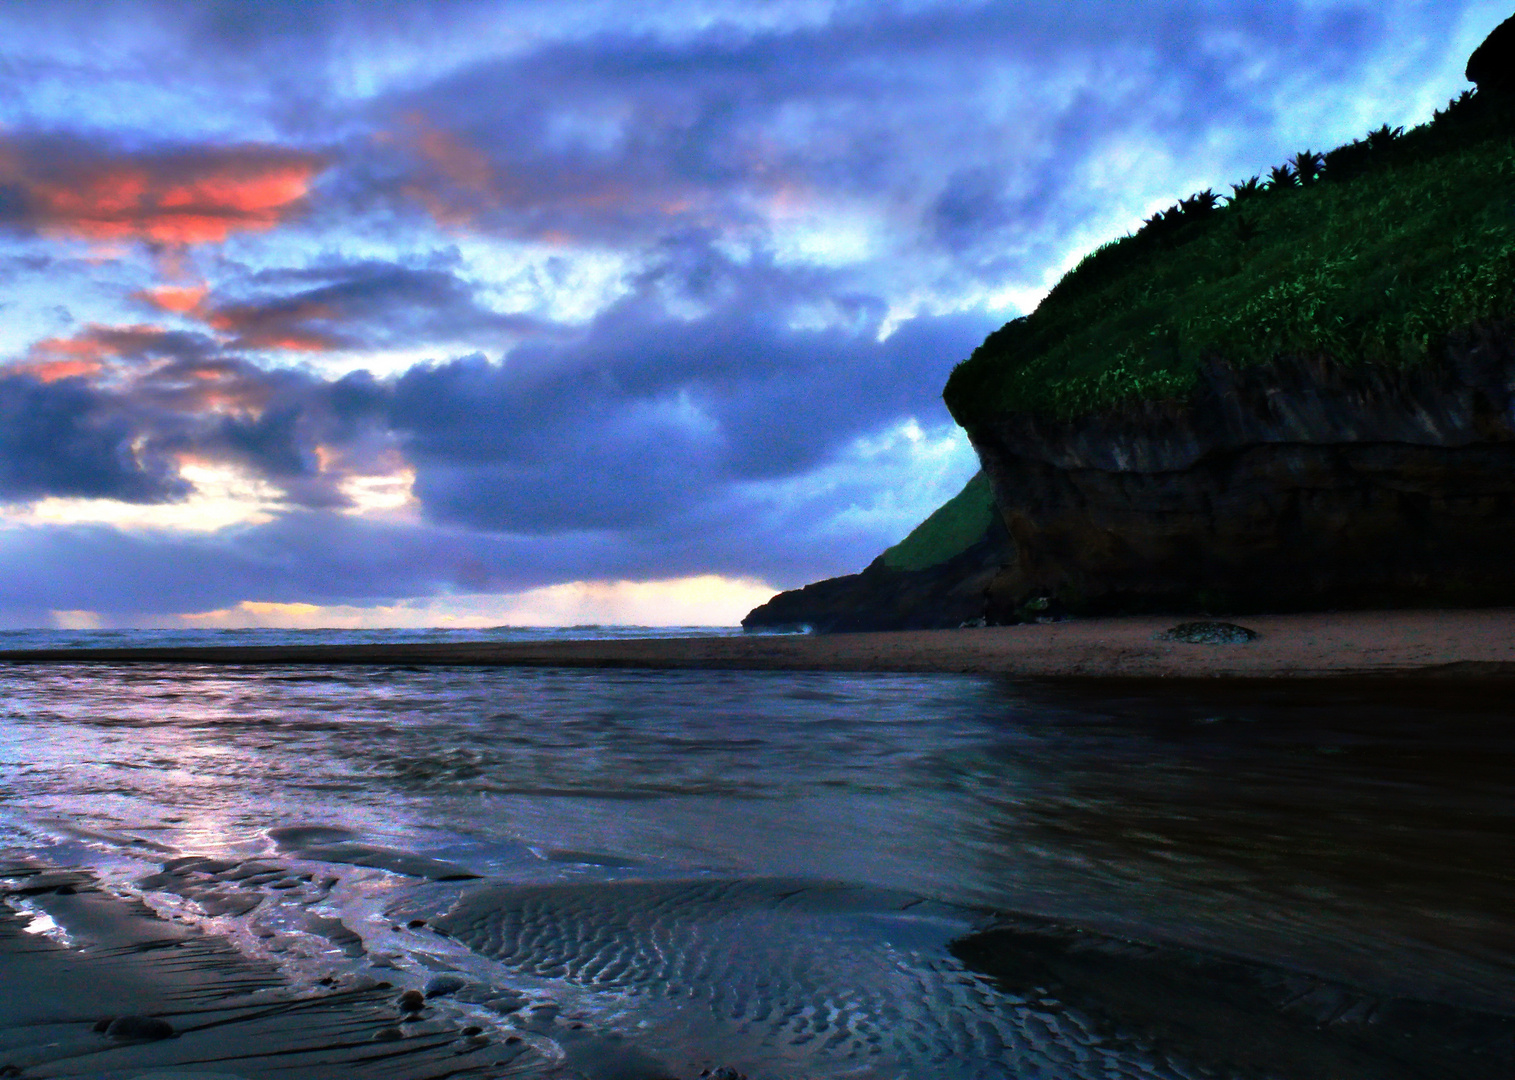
[0,863,542,1080]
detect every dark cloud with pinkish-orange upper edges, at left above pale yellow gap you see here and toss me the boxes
[0,327,389,506]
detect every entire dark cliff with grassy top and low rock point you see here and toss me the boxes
[744,18,1515,630]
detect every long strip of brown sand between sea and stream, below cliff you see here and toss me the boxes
[0,607,1515,682]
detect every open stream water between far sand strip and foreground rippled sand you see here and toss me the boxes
[0,666,1515,1004]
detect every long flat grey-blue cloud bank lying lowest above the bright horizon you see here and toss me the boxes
[0,466,915,624]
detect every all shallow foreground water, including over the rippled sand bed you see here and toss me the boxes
[0,654,1515,1080]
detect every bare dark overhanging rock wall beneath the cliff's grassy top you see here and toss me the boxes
[970,321,1515,621]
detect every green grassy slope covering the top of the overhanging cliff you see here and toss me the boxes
[942,94,1515,430]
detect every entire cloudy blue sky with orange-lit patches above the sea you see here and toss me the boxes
[0,0,1510,629]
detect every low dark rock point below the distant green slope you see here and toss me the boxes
[742,518,1015,633]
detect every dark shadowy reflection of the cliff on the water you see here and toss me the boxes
[974,683,1515,1007]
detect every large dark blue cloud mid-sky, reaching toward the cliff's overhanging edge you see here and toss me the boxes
[392,242,992,533]
